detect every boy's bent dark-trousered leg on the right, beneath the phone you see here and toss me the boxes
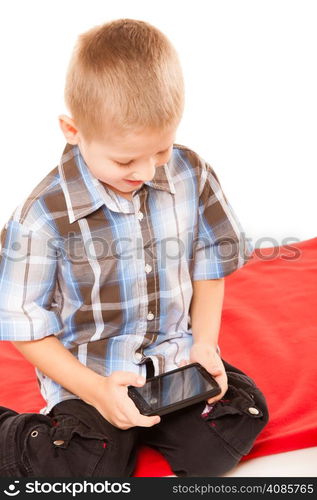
[142,360,268,477]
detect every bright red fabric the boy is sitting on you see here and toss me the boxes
[0,238,317,477]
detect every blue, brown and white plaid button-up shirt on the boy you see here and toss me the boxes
[0,144,251,414]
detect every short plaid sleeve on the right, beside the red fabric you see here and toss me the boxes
[192,162,253,281]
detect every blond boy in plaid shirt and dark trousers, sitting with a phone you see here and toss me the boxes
[0,19,268,477]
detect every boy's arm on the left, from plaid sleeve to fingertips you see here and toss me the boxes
[0,220,159,429]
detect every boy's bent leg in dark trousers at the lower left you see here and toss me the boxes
[0,399,138,478]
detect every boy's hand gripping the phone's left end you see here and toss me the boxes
[87,371,161,430]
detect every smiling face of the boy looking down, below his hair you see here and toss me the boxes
[59,117,176,199]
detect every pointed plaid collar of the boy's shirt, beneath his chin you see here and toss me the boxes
[58,143,175,223]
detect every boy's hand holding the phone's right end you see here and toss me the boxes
[179,343,228,404]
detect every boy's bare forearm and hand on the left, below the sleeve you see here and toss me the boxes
[12,335,160,430]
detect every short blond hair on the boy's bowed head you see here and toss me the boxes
[64,19,184,142]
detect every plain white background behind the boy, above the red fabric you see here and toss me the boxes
[0,0,317,246]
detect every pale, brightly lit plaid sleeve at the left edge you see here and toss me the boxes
[0,219,62,341]
